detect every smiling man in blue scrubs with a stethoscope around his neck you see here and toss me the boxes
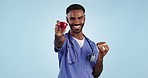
[54,4,109,78]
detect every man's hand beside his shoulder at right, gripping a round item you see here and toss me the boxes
[97,42,109,57]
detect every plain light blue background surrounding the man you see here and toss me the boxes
[0,0,148,78]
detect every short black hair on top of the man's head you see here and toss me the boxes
[66,4,85,14]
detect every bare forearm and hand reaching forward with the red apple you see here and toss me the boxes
[54,21,66,48]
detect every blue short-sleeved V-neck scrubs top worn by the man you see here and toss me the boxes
[54,33,99,78]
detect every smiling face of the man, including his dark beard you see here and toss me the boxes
[66,10,85,33]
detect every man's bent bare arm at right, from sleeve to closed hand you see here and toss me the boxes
[93,42,109,78]
